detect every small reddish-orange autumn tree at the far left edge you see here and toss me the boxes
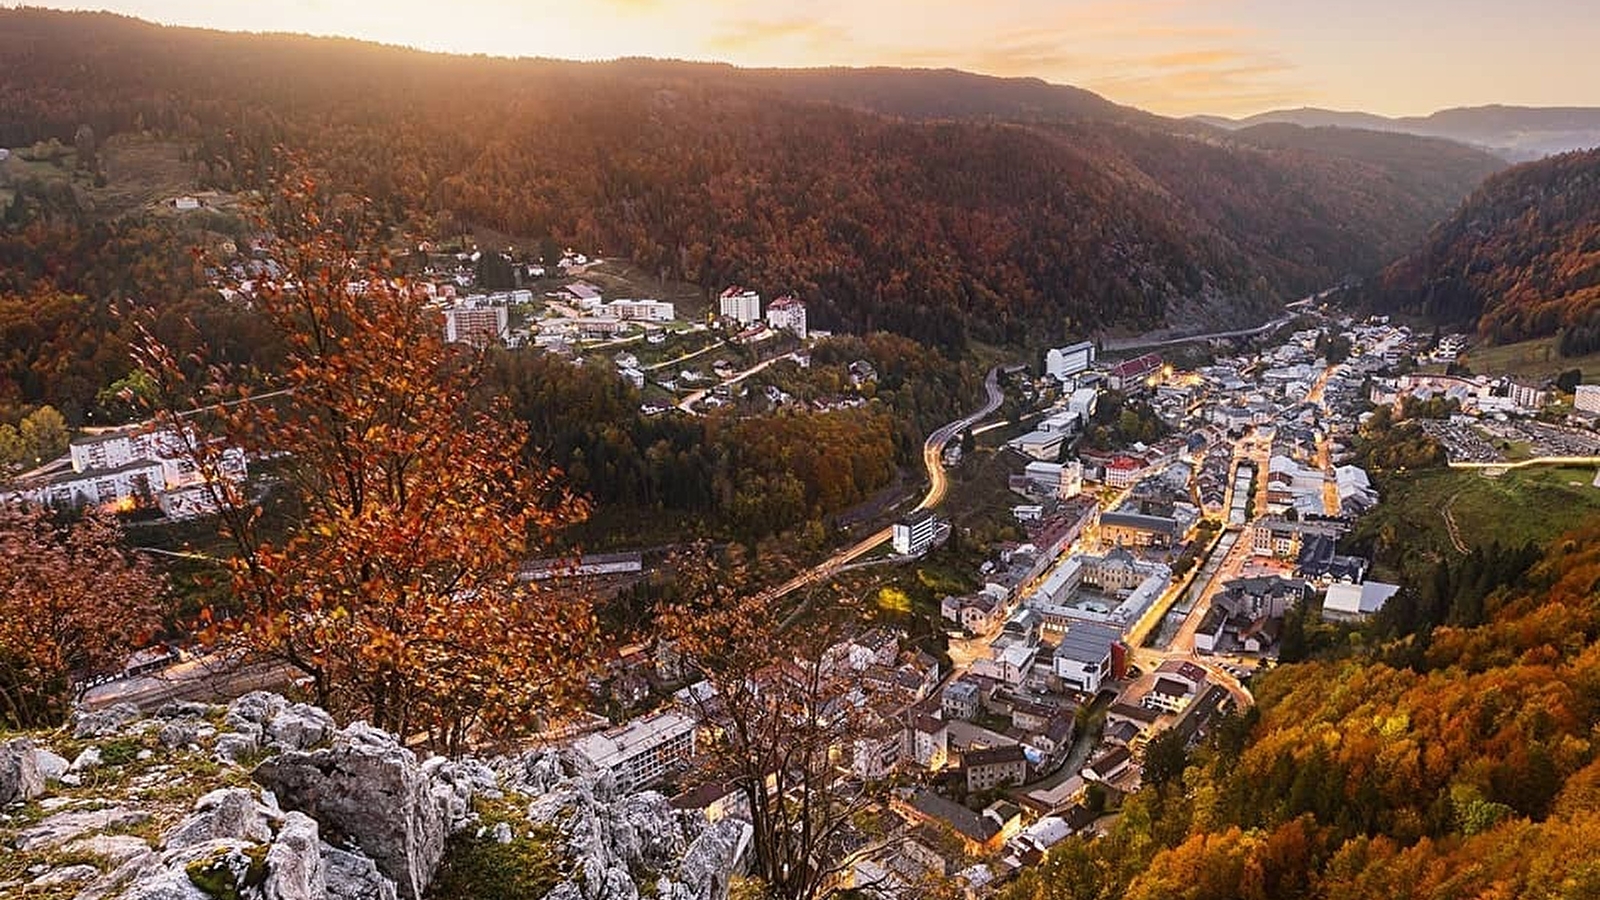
[0,504,163,729]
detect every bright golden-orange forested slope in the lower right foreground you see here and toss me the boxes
[1006,527,1600,900]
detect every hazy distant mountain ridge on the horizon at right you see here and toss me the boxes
[1190,106,1600,162]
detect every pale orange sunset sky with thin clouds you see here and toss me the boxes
[34,0,1600,115]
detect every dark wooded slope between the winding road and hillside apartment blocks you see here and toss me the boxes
[486,335,982,551]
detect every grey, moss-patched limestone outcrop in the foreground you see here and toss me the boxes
[0,693,749,900]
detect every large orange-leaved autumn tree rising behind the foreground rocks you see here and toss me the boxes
[139,178,594,751]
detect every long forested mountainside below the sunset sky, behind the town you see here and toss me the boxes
[0,10,1498,349]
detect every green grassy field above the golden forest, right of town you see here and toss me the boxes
[1354,466,1600,580]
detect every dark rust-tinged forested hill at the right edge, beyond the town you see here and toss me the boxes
[1368,151,1600,356]
